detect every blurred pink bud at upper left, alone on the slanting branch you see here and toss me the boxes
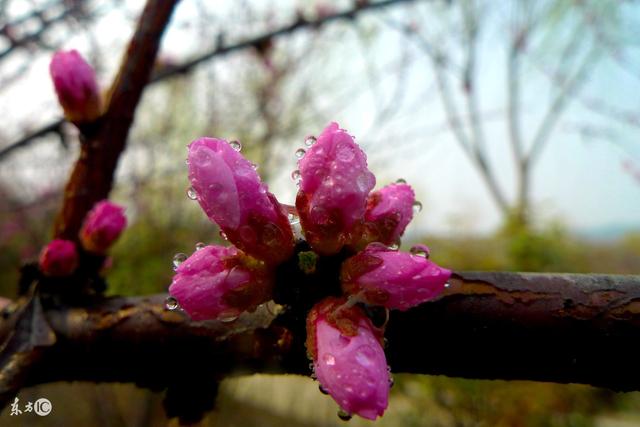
[49,50,101,123]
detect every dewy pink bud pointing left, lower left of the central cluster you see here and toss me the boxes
[169,246,273,320]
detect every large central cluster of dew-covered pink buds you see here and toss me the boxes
[167,123,451,420]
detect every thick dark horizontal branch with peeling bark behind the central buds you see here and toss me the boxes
[7,272,640,391]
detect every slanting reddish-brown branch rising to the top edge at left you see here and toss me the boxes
[55,0,178,240]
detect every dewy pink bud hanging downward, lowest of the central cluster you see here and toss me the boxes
[307,298,390,420]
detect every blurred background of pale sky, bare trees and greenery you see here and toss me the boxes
[0,0,640,426]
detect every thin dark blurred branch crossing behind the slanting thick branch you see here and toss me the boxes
[0,0,426,161]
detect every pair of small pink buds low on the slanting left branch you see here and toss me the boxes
[39,200,127,277]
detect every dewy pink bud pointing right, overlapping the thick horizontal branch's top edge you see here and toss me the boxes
[340,243,451,310]
